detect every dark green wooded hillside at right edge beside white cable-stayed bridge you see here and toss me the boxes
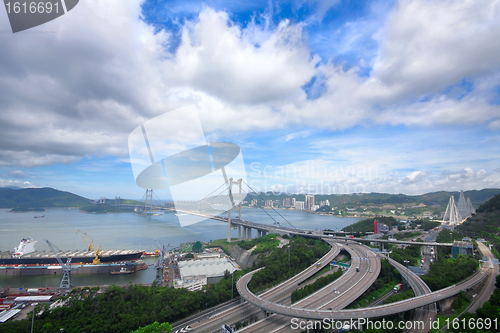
[457,194,500,254]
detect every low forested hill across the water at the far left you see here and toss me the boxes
[0,187,90,208]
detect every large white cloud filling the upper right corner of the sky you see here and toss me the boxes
[373,0,500,96]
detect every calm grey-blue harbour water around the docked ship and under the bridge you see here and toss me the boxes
[0,208,359,288]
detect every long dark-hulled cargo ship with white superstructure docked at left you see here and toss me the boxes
[0,238,144,266]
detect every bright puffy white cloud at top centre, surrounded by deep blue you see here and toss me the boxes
[174,8,315,104]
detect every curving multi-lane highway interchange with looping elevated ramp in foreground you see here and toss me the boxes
[173,233,498,332]
